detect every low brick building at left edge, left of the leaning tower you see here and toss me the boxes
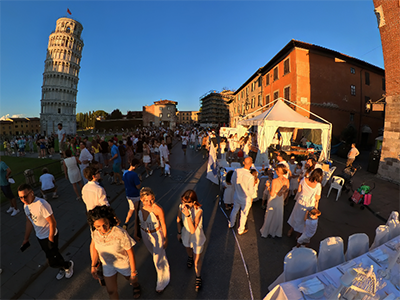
[0,118,40,136]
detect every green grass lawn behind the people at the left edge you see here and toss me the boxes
[0,156,63,203]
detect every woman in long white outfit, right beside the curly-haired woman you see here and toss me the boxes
[134,187,170,293]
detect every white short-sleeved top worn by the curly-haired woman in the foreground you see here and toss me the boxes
[92,226,136,269]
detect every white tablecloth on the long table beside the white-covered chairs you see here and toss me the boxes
[264,236,400,300]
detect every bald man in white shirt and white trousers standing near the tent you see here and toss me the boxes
[229,157,255,235]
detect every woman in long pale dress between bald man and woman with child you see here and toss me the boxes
[260,164,289,238]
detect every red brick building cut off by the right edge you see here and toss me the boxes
[374,0,400,183]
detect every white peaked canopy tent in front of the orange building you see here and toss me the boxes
[238,98,332,163]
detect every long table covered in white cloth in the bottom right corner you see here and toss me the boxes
[264,236,400,300]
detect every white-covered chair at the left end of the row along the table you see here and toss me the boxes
[283,248,317,282]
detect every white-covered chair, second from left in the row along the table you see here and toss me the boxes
[318,236,345,272]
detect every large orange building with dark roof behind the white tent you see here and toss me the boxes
[229,40,385,148]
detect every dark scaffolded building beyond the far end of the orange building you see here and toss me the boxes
[199,90,234,125]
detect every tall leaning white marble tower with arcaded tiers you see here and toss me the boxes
[40,18,83,134]
